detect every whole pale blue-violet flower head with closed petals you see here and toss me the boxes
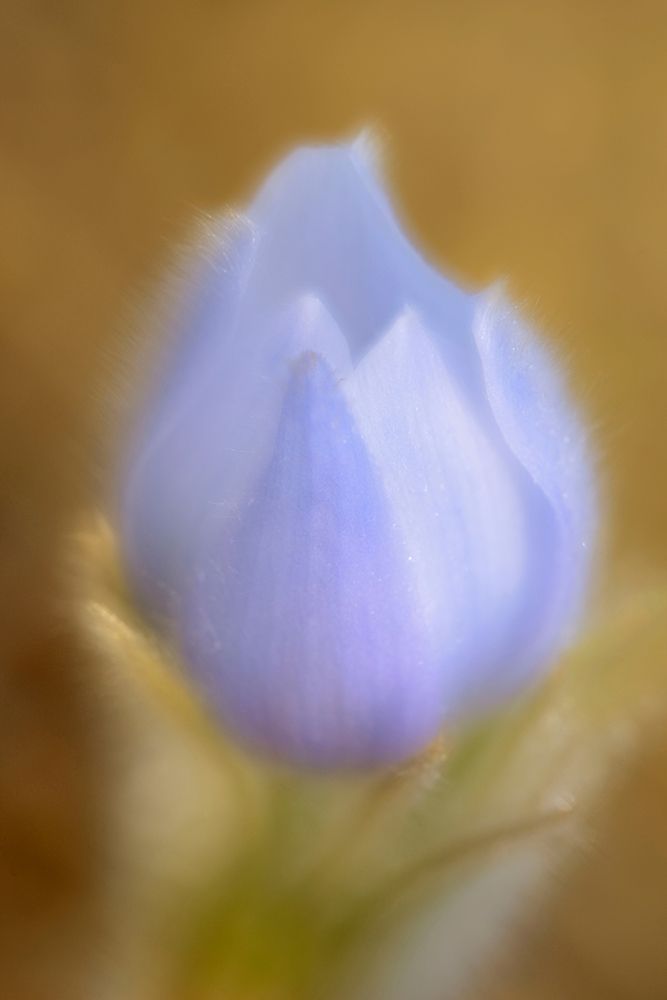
[119,137,594,766]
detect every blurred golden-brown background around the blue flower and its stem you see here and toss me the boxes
[0,0,667,1000]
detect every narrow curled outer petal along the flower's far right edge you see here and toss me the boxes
[474,291,596,651]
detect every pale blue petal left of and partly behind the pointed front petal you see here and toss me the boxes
[122,290,350,612]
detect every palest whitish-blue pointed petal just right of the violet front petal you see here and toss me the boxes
[346,311,555,716]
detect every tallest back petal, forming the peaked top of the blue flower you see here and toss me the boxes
[243,143,475,370]
